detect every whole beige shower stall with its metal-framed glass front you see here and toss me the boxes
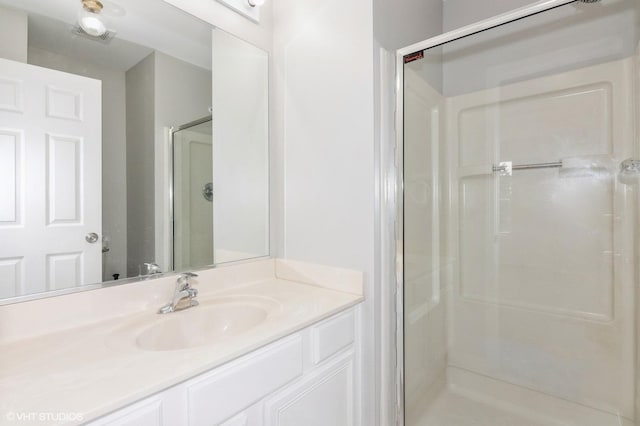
[397,0,640,426]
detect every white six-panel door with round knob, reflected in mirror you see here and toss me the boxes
[0,59,102,298]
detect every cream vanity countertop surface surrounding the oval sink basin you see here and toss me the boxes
[0,260,363,425]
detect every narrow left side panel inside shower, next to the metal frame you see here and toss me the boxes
[404,67,447,424]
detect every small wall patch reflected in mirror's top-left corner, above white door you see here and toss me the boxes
[0,7,28,62]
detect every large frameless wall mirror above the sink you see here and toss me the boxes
[0,0,269,303]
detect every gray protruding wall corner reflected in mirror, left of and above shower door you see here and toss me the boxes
[126,52,211,276]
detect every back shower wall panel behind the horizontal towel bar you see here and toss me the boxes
[447,59,635,418]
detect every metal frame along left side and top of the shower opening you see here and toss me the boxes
[392,0,579,426]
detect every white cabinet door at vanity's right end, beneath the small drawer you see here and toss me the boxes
[264,350,355,426]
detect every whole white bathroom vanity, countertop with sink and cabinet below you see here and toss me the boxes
[0,259,363,426]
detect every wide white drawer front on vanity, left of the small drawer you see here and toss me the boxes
[187,335,303,426]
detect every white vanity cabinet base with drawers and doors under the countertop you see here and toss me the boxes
[90,308,358,426]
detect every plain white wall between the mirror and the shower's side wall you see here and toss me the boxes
[272,0,378,425]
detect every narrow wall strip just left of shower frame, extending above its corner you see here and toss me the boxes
[373,0,443,425]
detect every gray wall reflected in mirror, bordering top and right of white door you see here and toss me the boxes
[28,46,127,281]
